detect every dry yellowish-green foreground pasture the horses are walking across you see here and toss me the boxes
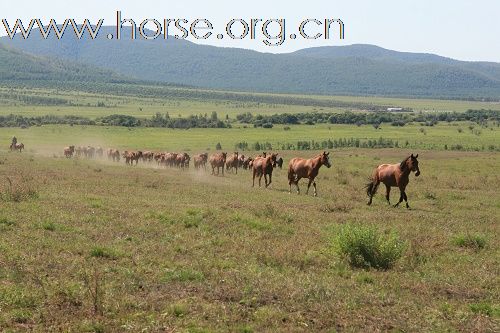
[0,148,500,332]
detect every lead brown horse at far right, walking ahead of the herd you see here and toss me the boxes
[366,154,420,208]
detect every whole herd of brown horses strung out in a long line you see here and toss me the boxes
[61,146,420,208]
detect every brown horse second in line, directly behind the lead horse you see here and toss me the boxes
[288,151,332,196]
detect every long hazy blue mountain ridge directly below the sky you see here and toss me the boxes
[0,27,500,98]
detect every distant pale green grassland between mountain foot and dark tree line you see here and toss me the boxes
[0,87,500,119]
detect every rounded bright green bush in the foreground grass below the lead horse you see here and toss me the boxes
[336,224,407,269]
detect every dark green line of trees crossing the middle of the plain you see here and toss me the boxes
[0,110,500,129]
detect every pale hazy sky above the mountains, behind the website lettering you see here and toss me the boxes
[0,0,500,62]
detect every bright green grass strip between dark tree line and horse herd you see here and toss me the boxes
[0,122,500,154]
